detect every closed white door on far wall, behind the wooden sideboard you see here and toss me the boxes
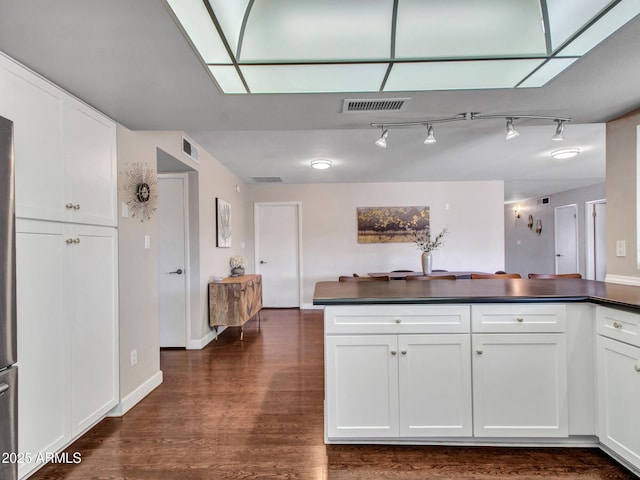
[255,203,300,308]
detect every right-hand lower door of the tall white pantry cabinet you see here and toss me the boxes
[67,225,118,436]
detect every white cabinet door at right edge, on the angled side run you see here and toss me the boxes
[597,336,640,468]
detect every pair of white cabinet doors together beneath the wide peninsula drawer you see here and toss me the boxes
[326,334,472,438]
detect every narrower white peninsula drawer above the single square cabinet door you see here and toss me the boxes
[471,303,566,333]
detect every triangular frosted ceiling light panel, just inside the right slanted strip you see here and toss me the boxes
[547,0,611,51]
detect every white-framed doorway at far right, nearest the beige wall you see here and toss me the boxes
[585,200,607,282]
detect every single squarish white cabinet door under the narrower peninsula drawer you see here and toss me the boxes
[472,334,568,437]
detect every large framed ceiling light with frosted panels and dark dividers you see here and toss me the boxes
[167,0,640,94]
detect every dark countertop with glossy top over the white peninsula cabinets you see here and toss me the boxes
[313,278,640,312]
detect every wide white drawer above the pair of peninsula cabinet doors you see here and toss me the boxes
[324,305,471,334]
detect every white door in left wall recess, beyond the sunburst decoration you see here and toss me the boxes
[158,174,188,347]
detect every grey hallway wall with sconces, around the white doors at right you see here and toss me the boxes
[504,183,609,278]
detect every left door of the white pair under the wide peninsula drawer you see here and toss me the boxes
[325,335,399,438]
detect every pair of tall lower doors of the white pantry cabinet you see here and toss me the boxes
[16,219,118,477]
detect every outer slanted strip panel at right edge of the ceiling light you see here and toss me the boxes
[560,0,640,56]
